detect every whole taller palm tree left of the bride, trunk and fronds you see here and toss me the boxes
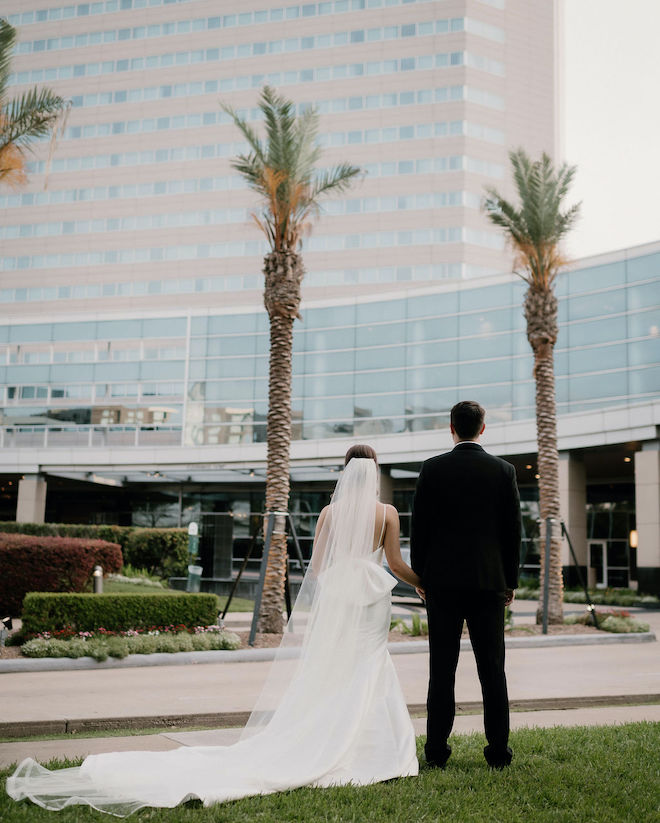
[223,86,360,633]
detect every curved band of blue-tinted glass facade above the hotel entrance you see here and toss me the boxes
[0,253,660,446]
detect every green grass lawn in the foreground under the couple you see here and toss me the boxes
[0,723,660,823]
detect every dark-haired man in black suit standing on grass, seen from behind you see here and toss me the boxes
[410,400,521,769]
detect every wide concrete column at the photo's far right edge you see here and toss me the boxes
[635,440,660,594]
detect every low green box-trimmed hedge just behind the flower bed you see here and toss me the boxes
[21,592,218,636]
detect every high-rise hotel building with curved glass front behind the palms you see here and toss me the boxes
[0,0,660,586]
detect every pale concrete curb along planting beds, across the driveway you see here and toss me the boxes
[0,632,657,674]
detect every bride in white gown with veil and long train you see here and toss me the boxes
[7,446,420,817]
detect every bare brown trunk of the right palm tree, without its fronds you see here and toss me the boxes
[524,286,564,623]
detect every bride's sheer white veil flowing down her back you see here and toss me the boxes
[242,458,396,739]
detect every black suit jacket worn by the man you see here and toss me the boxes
[410,442,521,591]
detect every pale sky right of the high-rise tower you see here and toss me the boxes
[560,0,660,257]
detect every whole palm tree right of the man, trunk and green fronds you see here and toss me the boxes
[484,149,580,623]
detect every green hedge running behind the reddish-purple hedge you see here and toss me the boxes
[0,521,188,577]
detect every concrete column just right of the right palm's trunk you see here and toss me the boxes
[559,452,588,586]
